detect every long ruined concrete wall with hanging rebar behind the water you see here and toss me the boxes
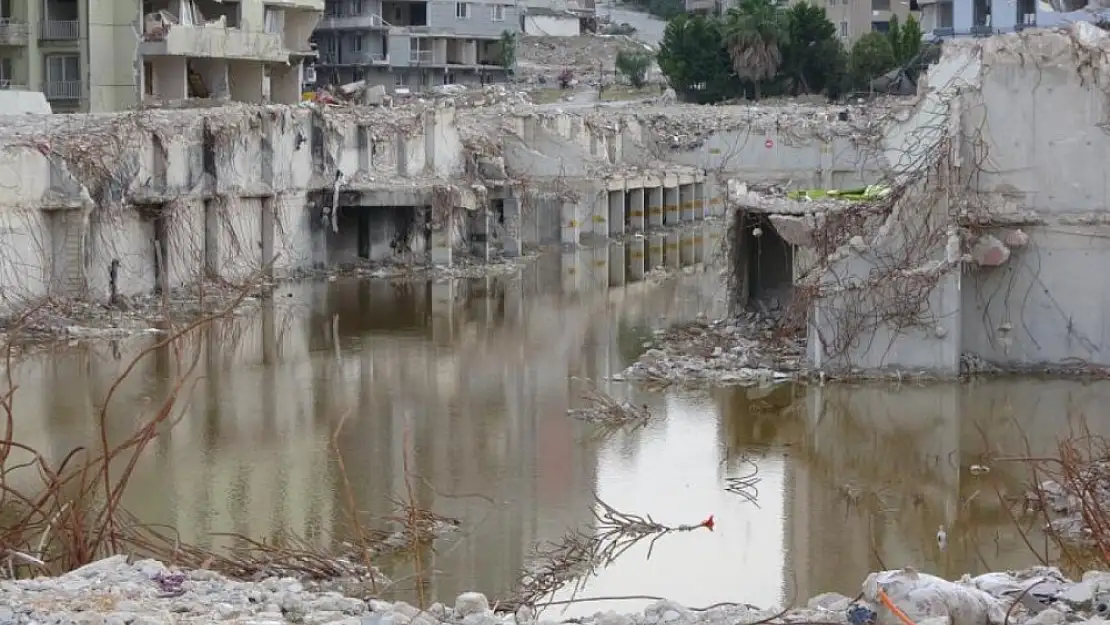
[0,94,878,309]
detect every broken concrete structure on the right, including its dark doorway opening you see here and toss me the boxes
[729,23,1110,375]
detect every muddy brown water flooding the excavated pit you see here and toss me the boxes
[6,238,1107,615]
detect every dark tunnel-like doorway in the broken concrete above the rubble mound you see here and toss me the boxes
[733,212,795,313]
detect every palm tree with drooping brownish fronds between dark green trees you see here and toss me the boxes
[725,0,788,100]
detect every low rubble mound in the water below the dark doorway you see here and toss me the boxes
[617,313,805,385]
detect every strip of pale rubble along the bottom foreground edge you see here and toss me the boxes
[0,556,1110,625]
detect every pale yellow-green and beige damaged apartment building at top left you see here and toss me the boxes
[0,0,323,112]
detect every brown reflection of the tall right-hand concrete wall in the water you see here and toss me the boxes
[718,380,1110,598]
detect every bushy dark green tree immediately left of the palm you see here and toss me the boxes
[656,14,737,103]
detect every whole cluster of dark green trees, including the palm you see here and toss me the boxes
[658,0,921,103]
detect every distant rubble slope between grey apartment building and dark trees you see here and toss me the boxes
[515,34,650,87]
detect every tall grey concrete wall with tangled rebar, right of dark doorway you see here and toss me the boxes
[810,23,1110,374]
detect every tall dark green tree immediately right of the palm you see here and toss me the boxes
[779,2,846,94]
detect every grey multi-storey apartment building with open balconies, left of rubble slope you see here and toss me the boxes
[314,0,523,91]
